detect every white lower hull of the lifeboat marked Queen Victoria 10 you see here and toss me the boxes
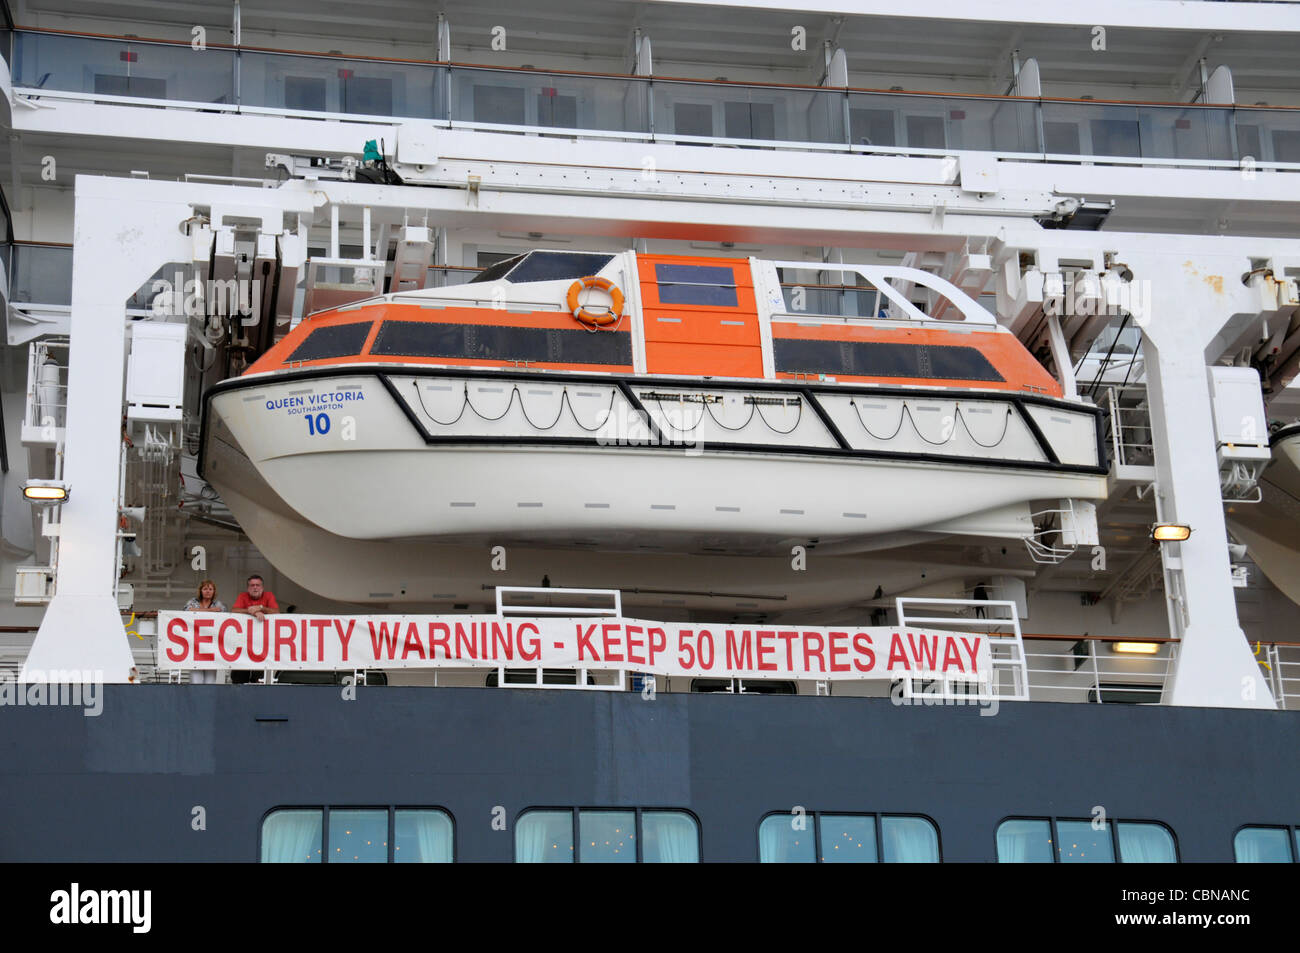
[203,367,1105,605]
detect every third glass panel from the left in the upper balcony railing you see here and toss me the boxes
[451,66,650,133]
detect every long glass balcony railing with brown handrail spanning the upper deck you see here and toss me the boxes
[9,29,1300,170]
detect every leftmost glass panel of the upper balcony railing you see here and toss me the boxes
[13,33,235,104]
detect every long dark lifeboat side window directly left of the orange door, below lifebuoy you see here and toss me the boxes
[371,321,632,367]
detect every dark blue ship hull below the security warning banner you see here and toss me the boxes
[0,685,1300,862]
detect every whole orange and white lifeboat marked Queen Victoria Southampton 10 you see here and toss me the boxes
[200,251,1108,607]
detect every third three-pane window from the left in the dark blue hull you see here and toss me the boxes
[758,810,940,863]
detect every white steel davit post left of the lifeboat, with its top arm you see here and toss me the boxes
[20,176,311,683]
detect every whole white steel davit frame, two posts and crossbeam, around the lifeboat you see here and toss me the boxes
[22,176,1300,707]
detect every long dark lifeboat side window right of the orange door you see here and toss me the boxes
[772,338,1006,381]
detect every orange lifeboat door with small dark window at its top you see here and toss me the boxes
[637,255,763,378]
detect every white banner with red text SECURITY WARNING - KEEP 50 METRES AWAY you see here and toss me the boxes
[157,612,991,681]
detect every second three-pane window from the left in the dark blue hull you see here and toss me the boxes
[515,807,699,863]
